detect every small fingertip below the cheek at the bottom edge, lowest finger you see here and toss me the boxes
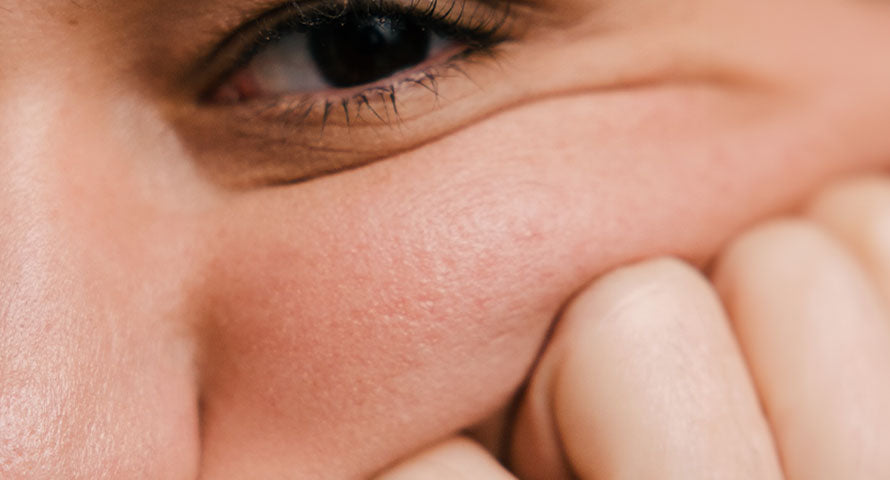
[376,437,516,480]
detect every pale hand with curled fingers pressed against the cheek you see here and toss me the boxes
[370,174,890,480]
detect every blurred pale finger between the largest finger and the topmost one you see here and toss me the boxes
[715,222,890,480]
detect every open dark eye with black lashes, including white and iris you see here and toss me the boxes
[200,0,509,103]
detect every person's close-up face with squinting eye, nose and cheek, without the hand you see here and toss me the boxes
[0,0,890,479]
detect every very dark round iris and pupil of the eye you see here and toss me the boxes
[308,15,431,88]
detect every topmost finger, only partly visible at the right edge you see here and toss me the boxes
[807,176,890,301]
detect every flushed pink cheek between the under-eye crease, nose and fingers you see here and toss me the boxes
[194,83,880,477]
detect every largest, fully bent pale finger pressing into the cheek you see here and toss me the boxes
[513,260,781,480]
